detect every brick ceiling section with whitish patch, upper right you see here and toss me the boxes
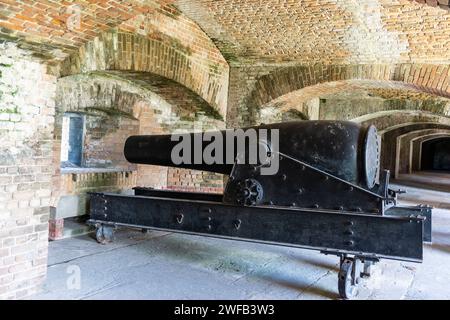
[175,0,450,64]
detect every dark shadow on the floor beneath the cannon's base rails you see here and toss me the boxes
[122,230,339,299]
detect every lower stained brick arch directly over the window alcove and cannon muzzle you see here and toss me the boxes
[56,71,223,122]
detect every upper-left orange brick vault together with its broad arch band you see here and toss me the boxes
[0,0,229,115]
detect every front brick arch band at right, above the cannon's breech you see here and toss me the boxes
[246,63,450,125]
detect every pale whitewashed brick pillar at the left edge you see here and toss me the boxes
[0,47,56,299]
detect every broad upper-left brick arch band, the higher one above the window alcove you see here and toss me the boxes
[59,17,229,117]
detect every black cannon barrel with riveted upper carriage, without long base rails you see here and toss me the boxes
[124,121,386,214]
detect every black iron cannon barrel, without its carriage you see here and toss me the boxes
[124,121,379,188]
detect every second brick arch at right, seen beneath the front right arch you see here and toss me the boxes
[257,80,450,123]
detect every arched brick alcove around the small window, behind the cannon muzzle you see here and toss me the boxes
[49,72,225,239]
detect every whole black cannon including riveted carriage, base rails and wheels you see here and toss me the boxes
[88,121,432,299]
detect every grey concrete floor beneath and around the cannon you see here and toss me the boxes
[33,176,450,299]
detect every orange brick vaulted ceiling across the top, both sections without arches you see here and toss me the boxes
[0,0,450,64]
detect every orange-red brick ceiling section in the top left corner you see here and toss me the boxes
[0,0,174,60]
